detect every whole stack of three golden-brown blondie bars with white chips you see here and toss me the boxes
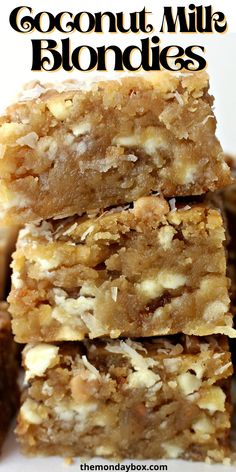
[0,72,236,462]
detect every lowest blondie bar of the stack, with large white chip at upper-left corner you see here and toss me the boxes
[17,335,232,462]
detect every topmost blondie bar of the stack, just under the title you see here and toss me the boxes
[0,71,231,223]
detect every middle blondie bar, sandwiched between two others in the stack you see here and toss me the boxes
[8,196,236,343]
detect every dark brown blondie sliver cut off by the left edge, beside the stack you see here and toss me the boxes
[0,302,19,448]
